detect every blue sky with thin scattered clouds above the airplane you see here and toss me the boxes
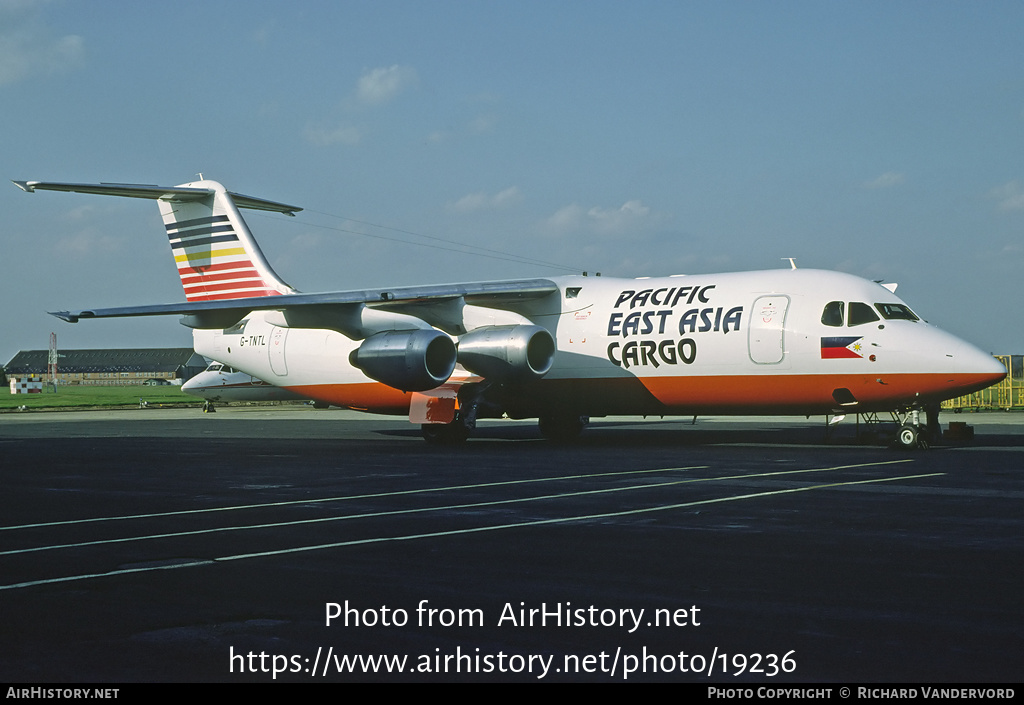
[0,0,1024,362]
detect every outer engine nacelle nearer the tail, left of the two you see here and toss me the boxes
[348,328,456,391]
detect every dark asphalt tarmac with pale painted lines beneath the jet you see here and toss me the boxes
[0,407,1024,685]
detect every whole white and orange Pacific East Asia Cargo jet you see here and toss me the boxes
[14,175,1007,448]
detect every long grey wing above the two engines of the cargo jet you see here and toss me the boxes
[50,279,558,328]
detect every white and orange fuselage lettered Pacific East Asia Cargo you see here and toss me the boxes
[195,269,1005,417]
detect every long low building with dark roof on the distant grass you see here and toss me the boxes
[5,347,206,386]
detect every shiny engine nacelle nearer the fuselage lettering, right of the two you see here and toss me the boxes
[459,325,555,382]
